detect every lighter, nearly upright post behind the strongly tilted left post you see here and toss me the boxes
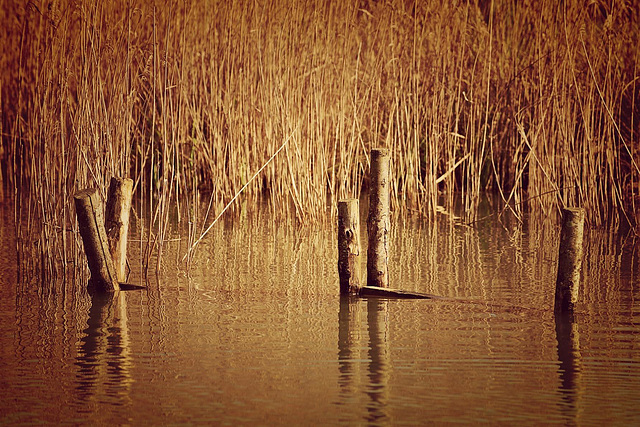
[105,177,133,282]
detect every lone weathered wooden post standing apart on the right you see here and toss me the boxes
[554,208,585,313]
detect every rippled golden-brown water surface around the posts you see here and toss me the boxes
[0,202,640,425]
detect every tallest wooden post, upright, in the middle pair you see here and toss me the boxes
[367,148,390,288]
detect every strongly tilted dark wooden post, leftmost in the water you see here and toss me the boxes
[74,188,120,292]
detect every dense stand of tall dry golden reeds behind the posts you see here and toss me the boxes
[0,0,640,278]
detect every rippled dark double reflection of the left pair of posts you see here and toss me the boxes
[76,291,133,412]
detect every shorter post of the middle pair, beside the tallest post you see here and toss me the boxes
[338,199,360,295]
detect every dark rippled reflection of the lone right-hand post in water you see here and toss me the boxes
[555,313,581,425]
